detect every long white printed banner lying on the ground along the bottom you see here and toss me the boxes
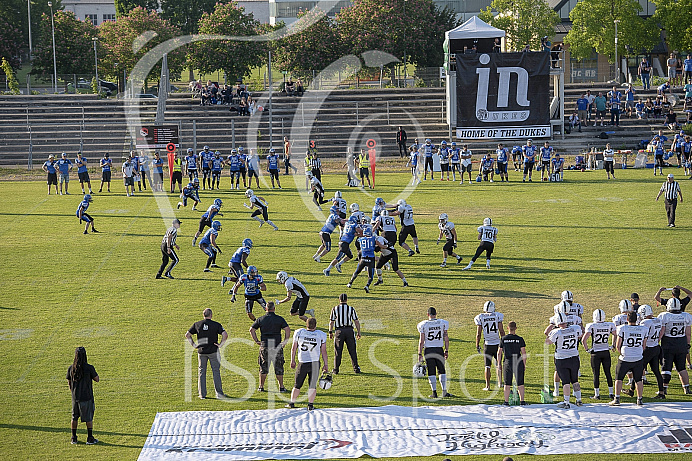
[139,402,692,461]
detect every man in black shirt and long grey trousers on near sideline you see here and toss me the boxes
[185,308,228,399]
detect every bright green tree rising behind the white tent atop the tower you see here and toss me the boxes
[478,0,560,51]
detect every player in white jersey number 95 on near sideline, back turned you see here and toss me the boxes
[610,311,649,406]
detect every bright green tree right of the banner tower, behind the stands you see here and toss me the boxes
[565,0,660,62]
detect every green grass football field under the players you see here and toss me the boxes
[0,169,692,460]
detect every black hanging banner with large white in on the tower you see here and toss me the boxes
[456,52,550,141]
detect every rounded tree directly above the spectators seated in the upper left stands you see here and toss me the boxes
[188,2,267,81]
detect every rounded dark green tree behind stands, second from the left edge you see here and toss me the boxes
[31,11,97,74]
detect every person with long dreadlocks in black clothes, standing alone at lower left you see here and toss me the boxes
[67,347,99,445]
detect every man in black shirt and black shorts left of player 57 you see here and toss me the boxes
[250,302,291,392]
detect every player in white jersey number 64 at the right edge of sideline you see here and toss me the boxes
[658,298,692,394]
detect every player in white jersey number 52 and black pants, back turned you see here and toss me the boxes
[545,312,582,408]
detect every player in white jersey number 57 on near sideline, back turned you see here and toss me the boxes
[286,317,329,411]
